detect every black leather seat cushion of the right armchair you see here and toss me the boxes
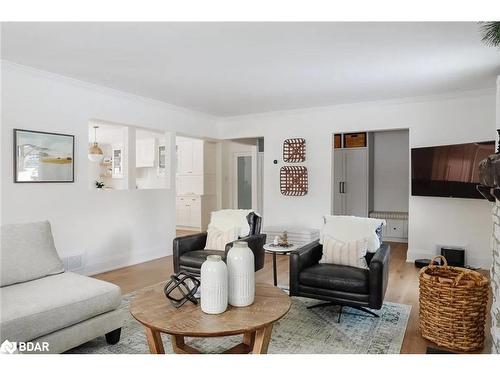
[299,264,369,294]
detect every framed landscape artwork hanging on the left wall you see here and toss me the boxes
[14,129,75,183]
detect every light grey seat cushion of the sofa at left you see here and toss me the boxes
[0,272,121,342]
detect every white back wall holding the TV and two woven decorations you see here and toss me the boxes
[219,90,495,267]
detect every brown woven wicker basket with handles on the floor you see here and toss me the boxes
[419,256,489,352]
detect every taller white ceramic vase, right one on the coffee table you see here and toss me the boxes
[226,241,255,307]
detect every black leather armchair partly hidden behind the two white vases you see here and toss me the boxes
[173,212,266,276]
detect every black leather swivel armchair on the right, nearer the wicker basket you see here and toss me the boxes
[290,241,390,321]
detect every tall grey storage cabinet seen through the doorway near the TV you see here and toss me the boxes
[332,133,370,217]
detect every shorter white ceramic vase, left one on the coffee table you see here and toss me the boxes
[201,255,228,314]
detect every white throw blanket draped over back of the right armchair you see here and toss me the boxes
[319,215,386,253]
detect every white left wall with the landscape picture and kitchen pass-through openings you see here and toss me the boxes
[1,62,215,274]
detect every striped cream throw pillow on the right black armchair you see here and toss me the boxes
[319,236,368,268]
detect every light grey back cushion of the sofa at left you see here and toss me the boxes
[0,221,64,287]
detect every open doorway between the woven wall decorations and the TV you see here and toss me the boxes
[331,129,410,242]
